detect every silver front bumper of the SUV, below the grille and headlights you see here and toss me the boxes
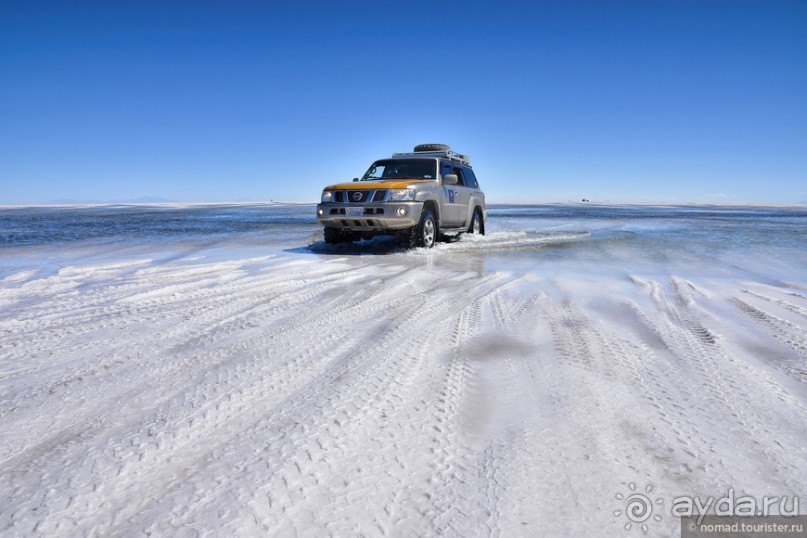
[317,202,423,231]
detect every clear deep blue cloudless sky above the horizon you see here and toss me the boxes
[0,0,807,204]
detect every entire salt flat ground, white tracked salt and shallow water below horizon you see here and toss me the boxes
[0,205,807,536]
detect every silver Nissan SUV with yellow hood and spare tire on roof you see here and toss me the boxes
[317,144,487,248]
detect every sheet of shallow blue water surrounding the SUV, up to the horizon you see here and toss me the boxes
[0,204,807,282]
